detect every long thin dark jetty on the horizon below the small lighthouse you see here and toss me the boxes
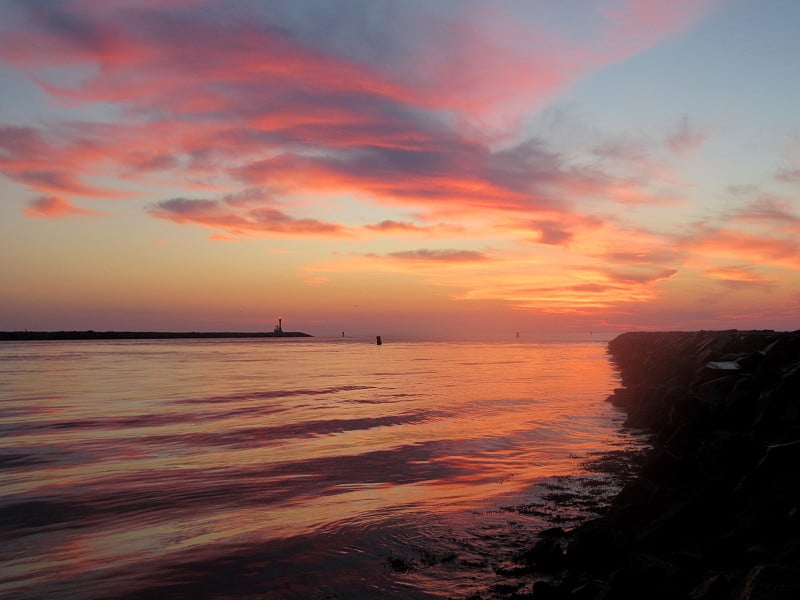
[0,330,313,341]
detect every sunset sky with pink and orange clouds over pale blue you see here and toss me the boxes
[0,0,800,339]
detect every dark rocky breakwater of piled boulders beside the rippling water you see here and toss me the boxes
[527,331,800,600]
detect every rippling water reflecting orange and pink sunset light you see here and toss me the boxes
[0,339,628,598]
